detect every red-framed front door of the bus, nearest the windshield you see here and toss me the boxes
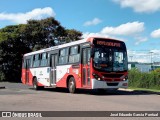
[82,48,91,87]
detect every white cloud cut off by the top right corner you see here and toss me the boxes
[112,0,160,13]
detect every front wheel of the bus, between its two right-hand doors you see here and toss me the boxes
[68,77,76,93]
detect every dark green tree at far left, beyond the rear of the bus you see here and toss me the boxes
[0,25,31,81]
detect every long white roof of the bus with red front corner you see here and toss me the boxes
[24,37,122,57]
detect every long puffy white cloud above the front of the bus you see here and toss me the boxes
[101,21,144,36]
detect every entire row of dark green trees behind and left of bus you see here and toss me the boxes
[0,17,82,82]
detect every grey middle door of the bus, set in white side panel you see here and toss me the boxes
[51,54,57,86]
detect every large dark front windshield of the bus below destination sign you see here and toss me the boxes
[93,47,128,72]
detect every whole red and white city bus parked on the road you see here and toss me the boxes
[21,37,128,93]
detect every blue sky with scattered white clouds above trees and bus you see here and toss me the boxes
[0,0,160,62]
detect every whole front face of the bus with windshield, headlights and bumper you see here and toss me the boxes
[91,39,128,89]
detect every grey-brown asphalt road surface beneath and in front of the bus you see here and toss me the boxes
[0,82,160,120]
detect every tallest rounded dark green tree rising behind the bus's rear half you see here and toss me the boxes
[23,17,65,50]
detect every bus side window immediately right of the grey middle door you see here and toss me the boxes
[59,48,68,64]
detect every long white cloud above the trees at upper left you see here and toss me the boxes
[0,7,55,24]
